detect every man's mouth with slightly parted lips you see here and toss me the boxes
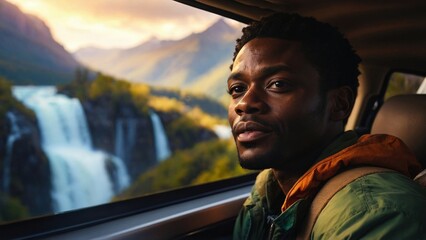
[233,121,272,143]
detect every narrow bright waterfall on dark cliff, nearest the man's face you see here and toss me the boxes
[150,111,171,161]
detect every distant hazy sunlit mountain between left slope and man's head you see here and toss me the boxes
[74,19,240,100]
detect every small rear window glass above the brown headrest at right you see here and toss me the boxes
[385,72,426,100]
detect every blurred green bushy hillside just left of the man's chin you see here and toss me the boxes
[118,140,249,199]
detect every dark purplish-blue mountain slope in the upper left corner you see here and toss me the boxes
[0,0,79,85]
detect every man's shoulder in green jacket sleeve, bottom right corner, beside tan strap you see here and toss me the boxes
[313,172,426,238]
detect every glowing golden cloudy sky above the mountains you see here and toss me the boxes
[7,0,235,52]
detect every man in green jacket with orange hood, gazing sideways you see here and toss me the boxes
[228,14,426,239]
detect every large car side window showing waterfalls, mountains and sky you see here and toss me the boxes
[0,0,247,223]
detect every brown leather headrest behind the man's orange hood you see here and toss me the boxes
[371,94,426,168]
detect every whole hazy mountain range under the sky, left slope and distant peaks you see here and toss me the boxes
[0,0,240,99]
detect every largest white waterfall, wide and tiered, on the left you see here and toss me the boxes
[13,86,130,212]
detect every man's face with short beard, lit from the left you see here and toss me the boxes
[228,38,328,170]
